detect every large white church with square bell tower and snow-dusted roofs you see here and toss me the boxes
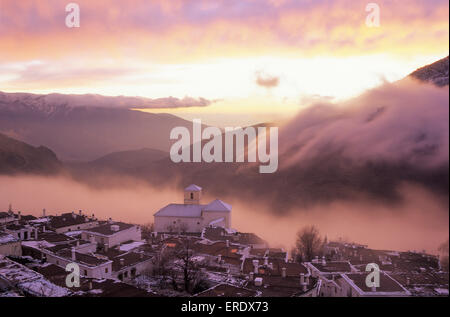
[154,184,231,232]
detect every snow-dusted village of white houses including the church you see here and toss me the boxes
[0,184,449,297]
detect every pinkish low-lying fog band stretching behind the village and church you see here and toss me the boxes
[0,176,449,254]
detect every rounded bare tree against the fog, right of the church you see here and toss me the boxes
[295,225,323,261]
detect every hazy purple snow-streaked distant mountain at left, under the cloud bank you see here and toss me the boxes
[0,93,199,160]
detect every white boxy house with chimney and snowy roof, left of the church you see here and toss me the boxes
[81,219,142,250]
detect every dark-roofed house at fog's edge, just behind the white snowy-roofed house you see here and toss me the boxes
[49,210,98,233]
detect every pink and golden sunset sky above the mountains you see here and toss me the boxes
[0,0,449,126]
